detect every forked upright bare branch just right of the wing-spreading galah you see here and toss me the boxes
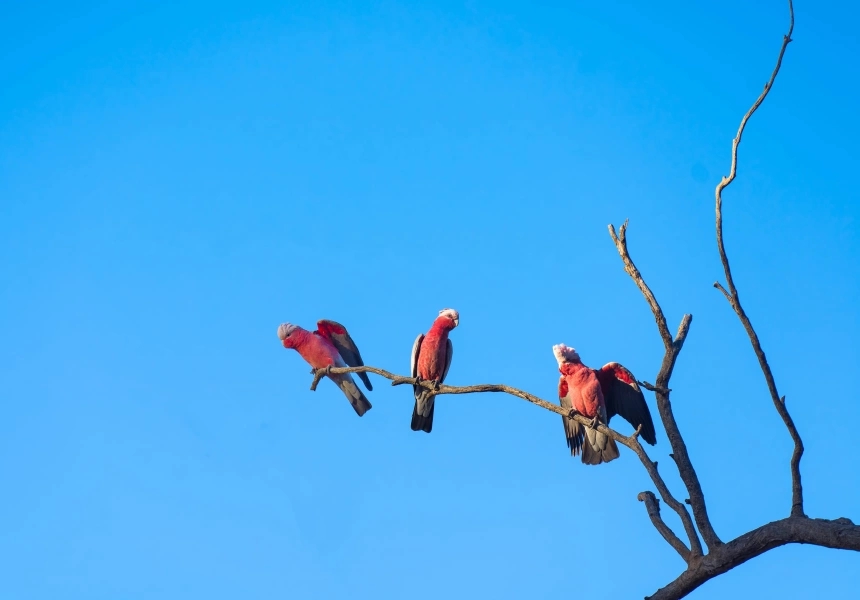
[609,221,722,557]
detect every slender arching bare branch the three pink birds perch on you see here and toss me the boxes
[311,360,702,562]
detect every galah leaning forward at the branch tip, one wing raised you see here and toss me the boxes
[278,321,371,417]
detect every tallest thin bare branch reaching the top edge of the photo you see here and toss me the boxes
[714,0,804,517]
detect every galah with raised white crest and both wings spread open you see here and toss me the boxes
[552,344,657,465]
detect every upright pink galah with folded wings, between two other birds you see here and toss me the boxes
[412,308,460,433]
